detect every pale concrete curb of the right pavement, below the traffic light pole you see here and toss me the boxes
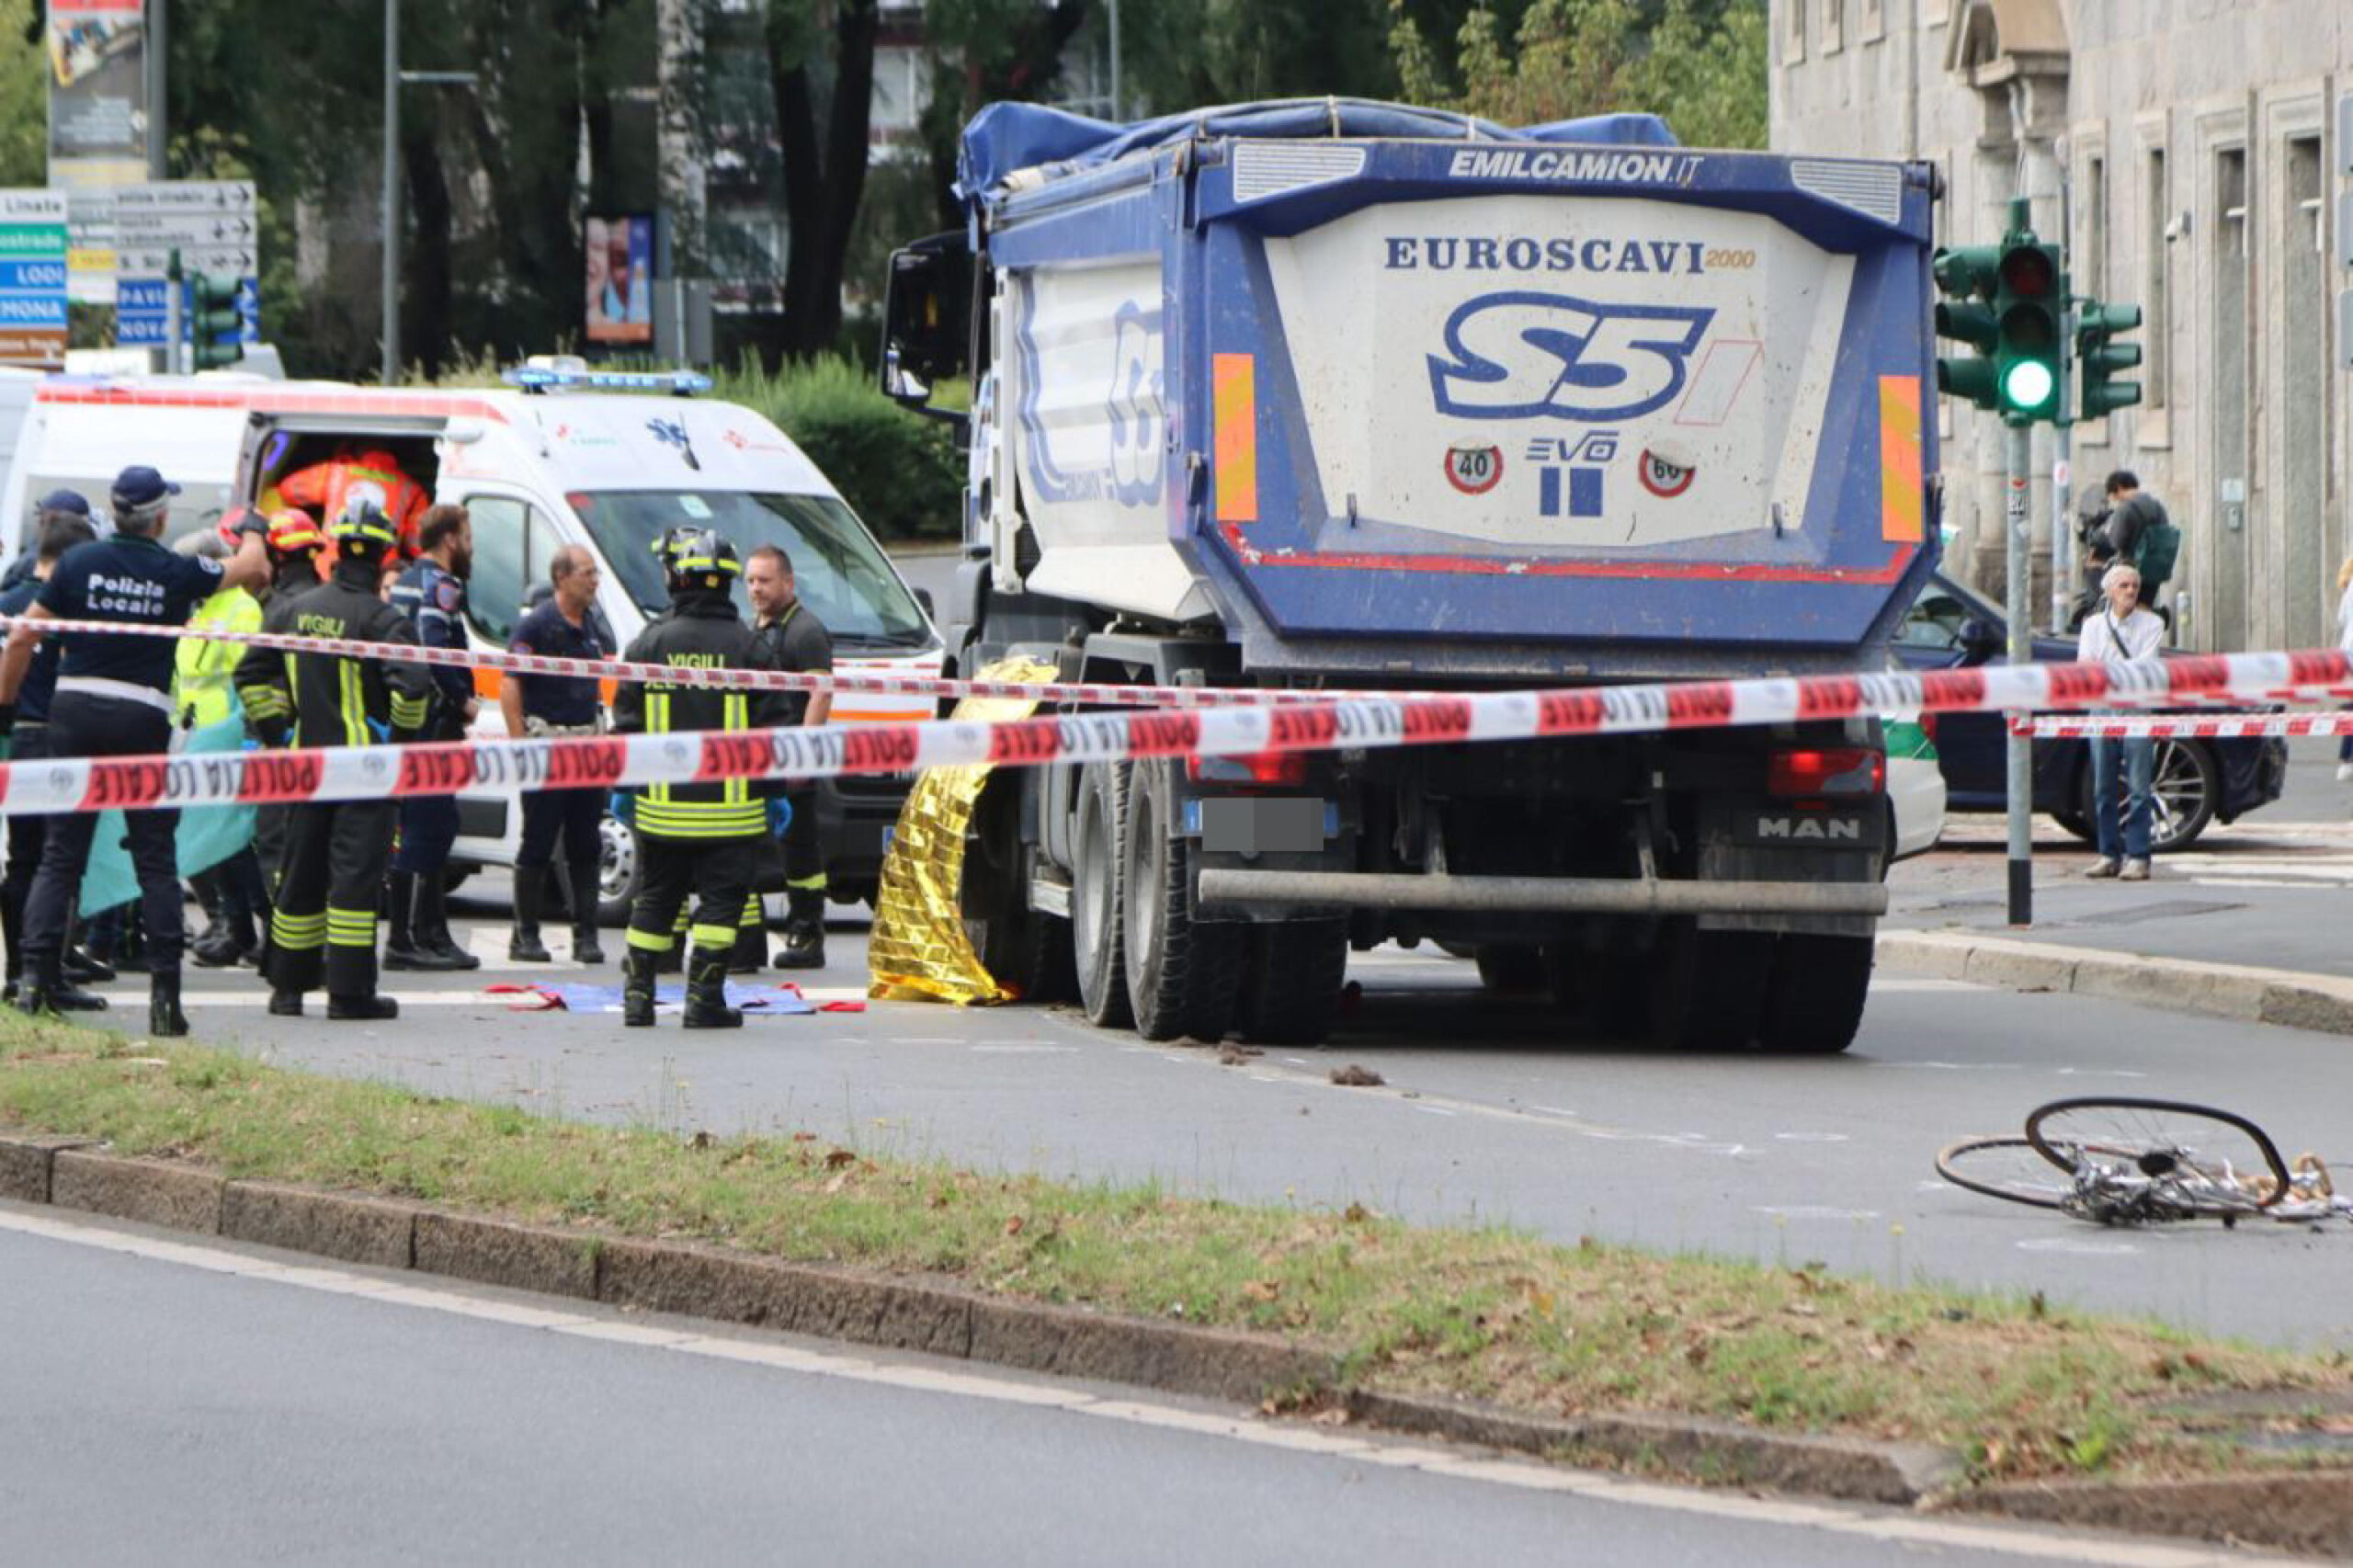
[1878,930,2353,1034]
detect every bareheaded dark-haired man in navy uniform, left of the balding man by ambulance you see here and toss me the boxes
[383,506,483,970]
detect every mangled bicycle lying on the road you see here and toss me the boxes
[1937,1097,2353,1227]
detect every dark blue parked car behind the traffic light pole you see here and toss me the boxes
[1894,572,2287,855]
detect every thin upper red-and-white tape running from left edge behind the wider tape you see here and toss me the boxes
[0,615,1332,709]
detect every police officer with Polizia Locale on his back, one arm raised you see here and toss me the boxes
[0,466,268,1036]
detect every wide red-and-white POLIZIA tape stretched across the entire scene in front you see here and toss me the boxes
[0,647,2353,814]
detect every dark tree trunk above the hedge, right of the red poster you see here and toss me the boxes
[765,0,880,360]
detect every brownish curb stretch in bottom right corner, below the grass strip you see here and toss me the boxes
[1944,1471,2353,1559]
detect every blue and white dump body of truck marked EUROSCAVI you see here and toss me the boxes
[965,101,1937,680]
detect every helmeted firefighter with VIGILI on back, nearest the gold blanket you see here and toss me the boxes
[612,529,783,1028]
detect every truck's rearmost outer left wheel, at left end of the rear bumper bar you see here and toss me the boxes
[1120,763,1249,1040]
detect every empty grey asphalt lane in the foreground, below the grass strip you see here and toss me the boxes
[0,1206,2235,1568]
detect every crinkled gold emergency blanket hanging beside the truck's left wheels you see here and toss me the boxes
[866,659,1054,1006]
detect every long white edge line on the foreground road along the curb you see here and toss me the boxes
[0,1206,2287,1568]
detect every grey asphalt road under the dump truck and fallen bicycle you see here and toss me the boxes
[127,857,2353,1345]
